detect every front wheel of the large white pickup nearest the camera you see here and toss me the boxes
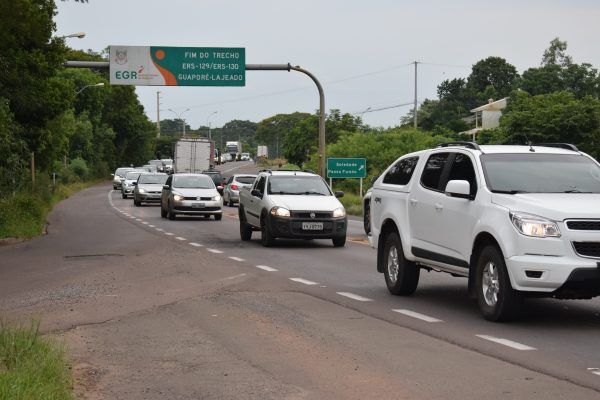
[475,245,523,322]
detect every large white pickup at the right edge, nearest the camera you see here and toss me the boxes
[368,142,600,321]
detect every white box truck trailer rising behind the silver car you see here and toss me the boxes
[173,138,215,173]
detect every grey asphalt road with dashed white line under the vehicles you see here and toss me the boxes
[0,163,600,399]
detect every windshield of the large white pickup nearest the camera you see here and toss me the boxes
[481,153,600,194]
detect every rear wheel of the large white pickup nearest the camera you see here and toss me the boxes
[383,232,420,295]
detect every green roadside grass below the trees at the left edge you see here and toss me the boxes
[0,181,97,239]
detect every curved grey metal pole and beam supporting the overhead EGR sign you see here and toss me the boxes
[64,61,326,177]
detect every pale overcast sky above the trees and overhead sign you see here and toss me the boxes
[56,0,600,129]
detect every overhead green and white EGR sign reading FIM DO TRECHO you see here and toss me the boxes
[110,46,246,86]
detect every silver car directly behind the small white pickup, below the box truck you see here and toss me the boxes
[160,174,223,221]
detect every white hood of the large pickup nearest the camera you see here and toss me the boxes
[492,193,600,221]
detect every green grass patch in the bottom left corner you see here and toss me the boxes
[0,321,74,400]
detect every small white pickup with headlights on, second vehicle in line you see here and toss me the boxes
[238,170,348,247]
